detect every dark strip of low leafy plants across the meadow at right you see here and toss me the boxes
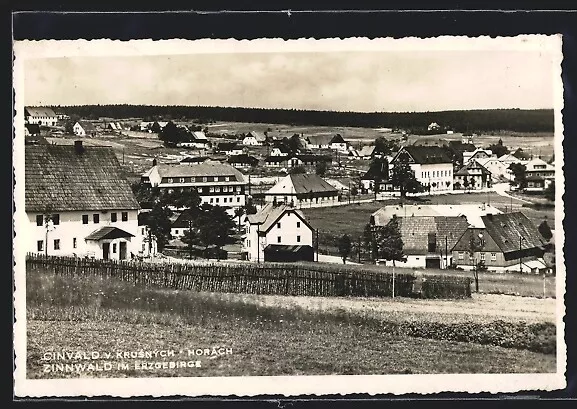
[382,320,556,354]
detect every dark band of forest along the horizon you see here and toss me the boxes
[55,105,554,134]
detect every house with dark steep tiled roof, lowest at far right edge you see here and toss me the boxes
[452,212,547,273]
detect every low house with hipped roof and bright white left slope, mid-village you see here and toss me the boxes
[264,173,339,208]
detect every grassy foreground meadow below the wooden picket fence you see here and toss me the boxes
[26,273,555,378]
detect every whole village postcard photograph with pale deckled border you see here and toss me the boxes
[13,35,566,396]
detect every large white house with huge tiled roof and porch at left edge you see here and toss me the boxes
[24,141,147,260]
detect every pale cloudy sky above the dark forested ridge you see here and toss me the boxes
[23,50,554,112]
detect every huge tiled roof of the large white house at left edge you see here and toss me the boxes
[24,145,139,212]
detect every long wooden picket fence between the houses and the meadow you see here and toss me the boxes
[26,254,468,297]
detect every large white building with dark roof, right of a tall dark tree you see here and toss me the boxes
[389,146,453,191]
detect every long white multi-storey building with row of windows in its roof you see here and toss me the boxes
[141,160,248,208]
